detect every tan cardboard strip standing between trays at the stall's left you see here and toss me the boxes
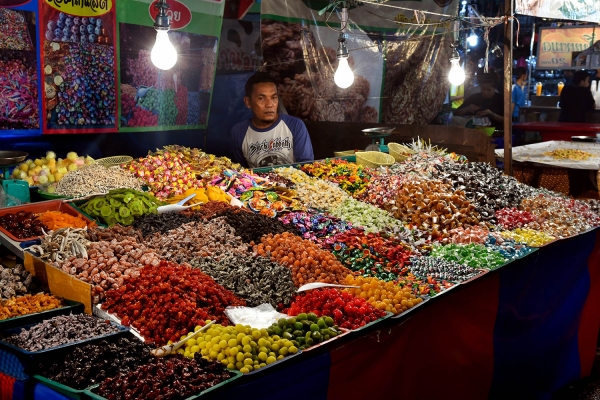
[23,251,93,314]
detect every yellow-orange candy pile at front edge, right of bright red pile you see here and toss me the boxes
[344,275,423,314]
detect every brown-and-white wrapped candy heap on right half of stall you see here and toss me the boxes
[394,180,479,238]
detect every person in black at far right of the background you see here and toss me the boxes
[558,70,596,122]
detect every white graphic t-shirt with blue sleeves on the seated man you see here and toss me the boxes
[231,115,314,168]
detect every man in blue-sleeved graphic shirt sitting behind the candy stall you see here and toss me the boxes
[231,72,314,168]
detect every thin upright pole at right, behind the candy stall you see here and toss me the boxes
[504,0,513,176]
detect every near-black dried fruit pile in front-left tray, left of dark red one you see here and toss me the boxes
[38,338,153,390]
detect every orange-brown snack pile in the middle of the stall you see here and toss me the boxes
[254,232,351,287]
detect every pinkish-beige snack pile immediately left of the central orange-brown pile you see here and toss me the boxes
[145,218,248,264]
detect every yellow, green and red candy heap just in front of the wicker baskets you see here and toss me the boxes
[300,159,371,196]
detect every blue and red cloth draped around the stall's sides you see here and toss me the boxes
[4,229,600,400]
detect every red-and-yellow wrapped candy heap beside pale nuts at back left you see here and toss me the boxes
[128,151,201,199]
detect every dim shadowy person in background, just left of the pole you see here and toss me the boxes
[454,72,504,126]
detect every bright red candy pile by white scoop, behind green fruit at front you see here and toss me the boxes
[287,289,386,329]
